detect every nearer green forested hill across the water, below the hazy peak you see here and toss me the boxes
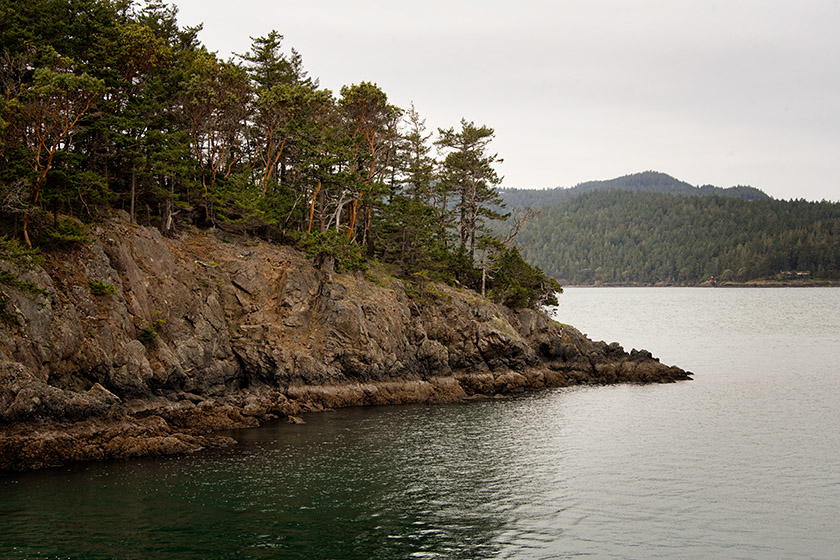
[516,191,840,285]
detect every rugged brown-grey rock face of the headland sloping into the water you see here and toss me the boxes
[0,219,689,469]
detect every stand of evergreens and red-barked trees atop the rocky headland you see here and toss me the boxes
[0,0,559,316]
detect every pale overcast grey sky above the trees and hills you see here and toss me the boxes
[170,0,840,201]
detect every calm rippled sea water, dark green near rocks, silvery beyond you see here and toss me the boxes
[0,288,840,559]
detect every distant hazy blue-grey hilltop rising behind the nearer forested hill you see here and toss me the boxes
[500,171,770,208]
